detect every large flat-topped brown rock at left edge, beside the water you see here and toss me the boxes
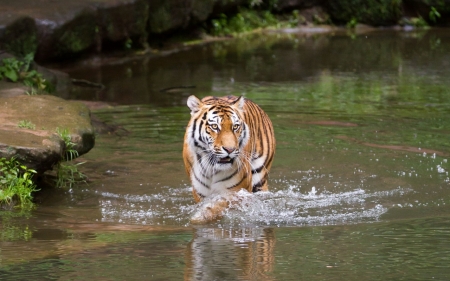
[0,95,95,173]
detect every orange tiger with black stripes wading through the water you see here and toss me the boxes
[183,95,275,222]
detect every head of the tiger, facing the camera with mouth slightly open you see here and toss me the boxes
[186,96,249,170]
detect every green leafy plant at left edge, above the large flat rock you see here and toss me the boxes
[0,54,51,91]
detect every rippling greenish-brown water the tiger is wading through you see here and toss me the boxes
[0,30,450,280]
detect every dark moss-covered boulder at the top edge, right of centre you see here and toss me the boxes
[326,0,402,26]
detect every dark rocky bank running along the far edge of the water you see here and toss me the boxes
[0,0,450,62]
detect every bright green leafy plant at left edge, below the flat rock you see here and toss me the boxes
[0,157,37,208]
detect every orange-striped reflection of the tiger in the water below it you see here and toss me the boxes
[184,228,275,281]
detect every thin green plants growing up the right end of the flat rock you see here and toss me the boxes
[56,128,86,188]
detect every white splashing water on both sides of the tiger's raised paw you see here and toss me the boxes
[100,185,411,227]
